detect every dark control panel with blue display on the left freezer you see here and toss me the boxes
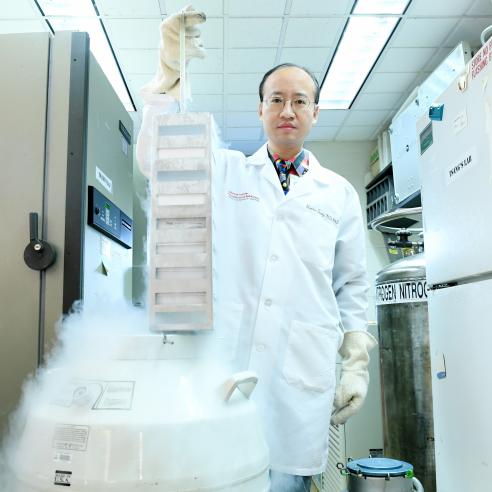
[87,186,133,249]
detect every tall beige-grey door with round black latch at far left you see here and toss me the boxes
[0,33,49,433]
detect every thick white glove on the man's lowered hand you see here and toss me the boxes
[331,331,378,425]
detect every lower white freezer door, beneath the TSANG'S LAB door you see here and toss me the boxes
[428,280,492,492]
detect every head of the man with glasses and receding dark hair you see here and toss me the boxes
[258,67,319,152]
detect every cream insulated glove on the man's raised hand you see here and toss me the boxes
[142,5,206,100]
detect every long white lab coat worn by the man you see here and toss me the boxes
[212,145,368,475]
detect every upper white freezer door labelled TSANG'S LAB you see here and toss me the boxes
[417,42,492,284]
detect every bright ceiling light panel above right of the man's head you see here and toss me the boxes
[320,0,409,109]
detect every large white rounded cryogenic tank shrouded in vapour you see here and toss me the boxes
[9,335,269,492]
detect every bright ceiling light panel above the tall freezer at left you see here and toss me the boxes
[38,0,135,111]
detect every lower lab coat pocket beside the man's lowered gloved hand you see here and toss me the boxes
[283,321,340,392]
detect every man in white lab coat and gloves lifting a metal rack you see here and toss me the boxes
[137,8,376,486]
